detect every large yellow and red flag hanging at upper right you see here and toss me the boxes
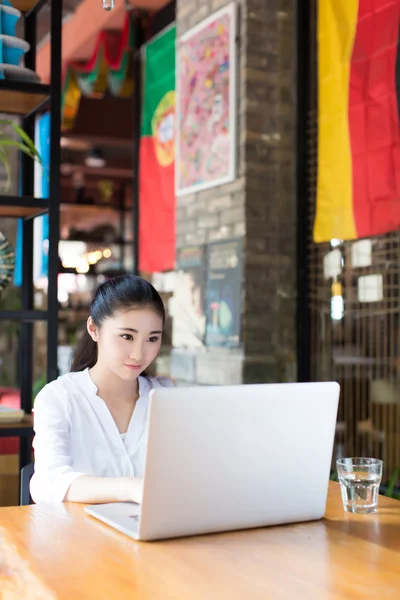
[314,0,400,242]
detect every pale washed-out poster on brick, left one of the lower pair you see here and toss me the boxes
[172,246,206,348]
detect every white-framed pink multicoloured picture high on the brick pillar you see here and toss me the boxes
[175,4,236,195]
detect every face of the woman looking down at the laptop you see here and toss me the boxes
[88,308,163,381]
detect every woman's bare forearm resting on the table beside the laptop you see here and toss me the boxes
[64,475,143,504]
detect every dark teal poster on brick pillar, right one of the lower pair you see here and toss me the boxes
[206,240,242,348]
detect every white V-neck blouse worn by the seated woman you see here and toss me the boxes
[30,369,173,503]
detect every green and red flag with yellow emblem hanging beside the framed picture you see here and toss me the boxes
[139,26,176,273]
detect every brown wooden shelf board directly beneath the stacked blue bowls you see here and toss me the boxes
[0,79,50,117]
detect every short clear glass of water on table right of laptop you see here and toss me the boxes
[336,458,383,513]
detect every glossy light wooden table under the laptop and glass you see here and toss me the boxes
[0,484,400,600]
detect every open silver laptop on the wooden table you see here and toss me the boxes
[85,383,339,540]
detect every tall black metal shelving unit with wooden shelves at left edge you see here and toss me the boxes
[0,0,62,478]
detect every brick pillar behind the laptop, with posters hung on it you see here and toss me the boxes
[172,0,296,384]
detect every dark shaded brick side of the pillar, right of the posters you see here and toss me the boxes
[243,0,296,381]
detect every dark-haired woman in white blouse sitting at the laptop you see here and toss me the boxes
[31,275,172,504]
